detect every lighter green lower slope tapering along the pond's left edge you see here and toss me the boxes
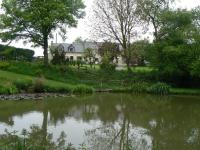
[0,70,93,94]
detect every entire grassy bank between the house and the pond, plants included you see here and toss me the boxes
[0,62,200,95]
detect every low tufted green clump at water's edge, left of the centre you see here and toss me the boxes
[73,85,94,94]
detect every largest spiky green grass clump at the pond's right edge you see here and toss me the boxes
[147,82,170,95]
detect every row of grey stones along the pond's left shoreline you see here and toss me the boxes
[0,93,69,101]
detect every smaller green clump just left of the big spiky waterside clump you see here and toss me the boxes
[131,82,148,93]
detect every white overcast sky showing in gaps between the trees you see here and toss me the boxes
[0,0,200,56]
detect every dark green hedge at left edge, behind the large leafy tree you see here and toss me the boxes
[0,44,35,61]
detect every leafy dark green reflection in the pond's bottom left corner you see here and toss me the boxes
[0,125,76,150]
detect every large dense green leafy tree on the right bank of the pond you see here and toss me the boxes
[147,10,200,86]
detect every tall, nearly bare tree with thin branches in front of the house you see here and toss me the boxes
[94,0,138,68]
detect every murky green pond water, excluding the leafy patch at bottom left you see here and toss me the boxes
[0,93,200,150]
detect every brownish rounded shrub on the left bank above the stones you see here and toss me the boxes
[33,78,45,93]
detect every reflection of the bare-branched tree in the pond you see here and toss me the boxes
[85,106,152,150]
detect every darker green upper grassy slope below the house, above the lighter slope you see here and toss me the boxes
[0,62,154,89]
